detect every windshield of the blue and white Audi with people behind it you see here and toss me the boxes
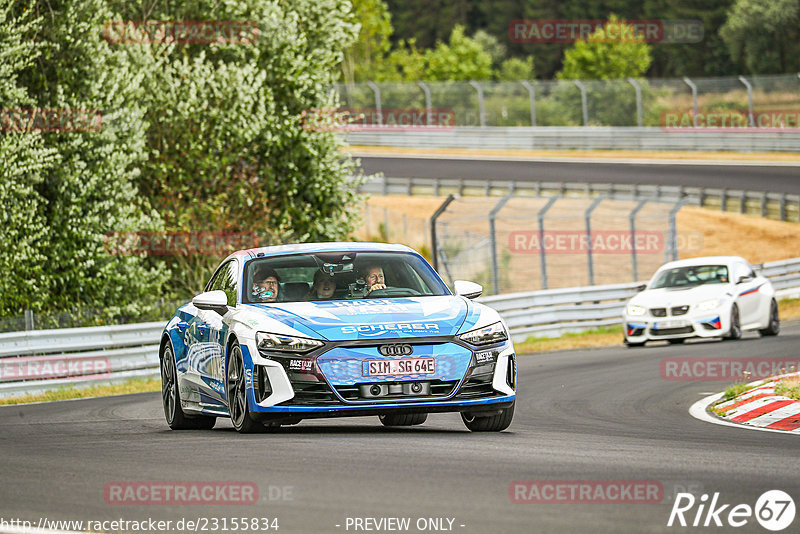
[242,252,450,304]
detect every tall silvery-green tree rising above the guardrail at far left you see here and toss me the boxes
[14,0,166,313]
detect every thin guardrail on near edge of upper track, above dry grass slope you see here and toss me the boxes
[359,176,800,221]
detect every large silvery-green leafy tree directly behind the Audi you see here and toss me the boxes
[121,0,358,295]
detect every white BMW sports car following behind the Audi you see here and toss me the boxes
[623,256,780,347]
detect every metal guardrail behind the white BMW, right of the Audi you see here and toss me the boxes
[478,258,800,341]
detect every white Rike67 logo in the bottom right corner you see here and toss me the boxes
[667,490,795,532]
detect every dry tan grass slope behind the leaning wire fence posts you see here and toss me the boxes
[355,195,800,292]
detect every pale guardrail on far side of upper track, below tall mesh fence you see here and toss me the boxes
[345,126,800,152]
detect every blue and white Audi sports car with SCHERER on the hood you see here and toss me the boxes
[160,243,516,432]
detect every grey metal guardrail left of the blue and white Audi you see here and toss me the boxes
[0,322,164,398]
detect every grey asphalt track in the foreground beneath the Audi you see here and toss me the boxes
[0,326,800,533]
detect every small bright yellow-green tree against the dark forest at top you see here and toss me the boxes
[556,15,652,80]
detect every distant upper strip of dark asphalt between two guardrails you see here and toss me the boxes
[359,154,800,194]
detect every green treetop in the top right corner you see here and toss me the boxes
[720,0,800,73]
